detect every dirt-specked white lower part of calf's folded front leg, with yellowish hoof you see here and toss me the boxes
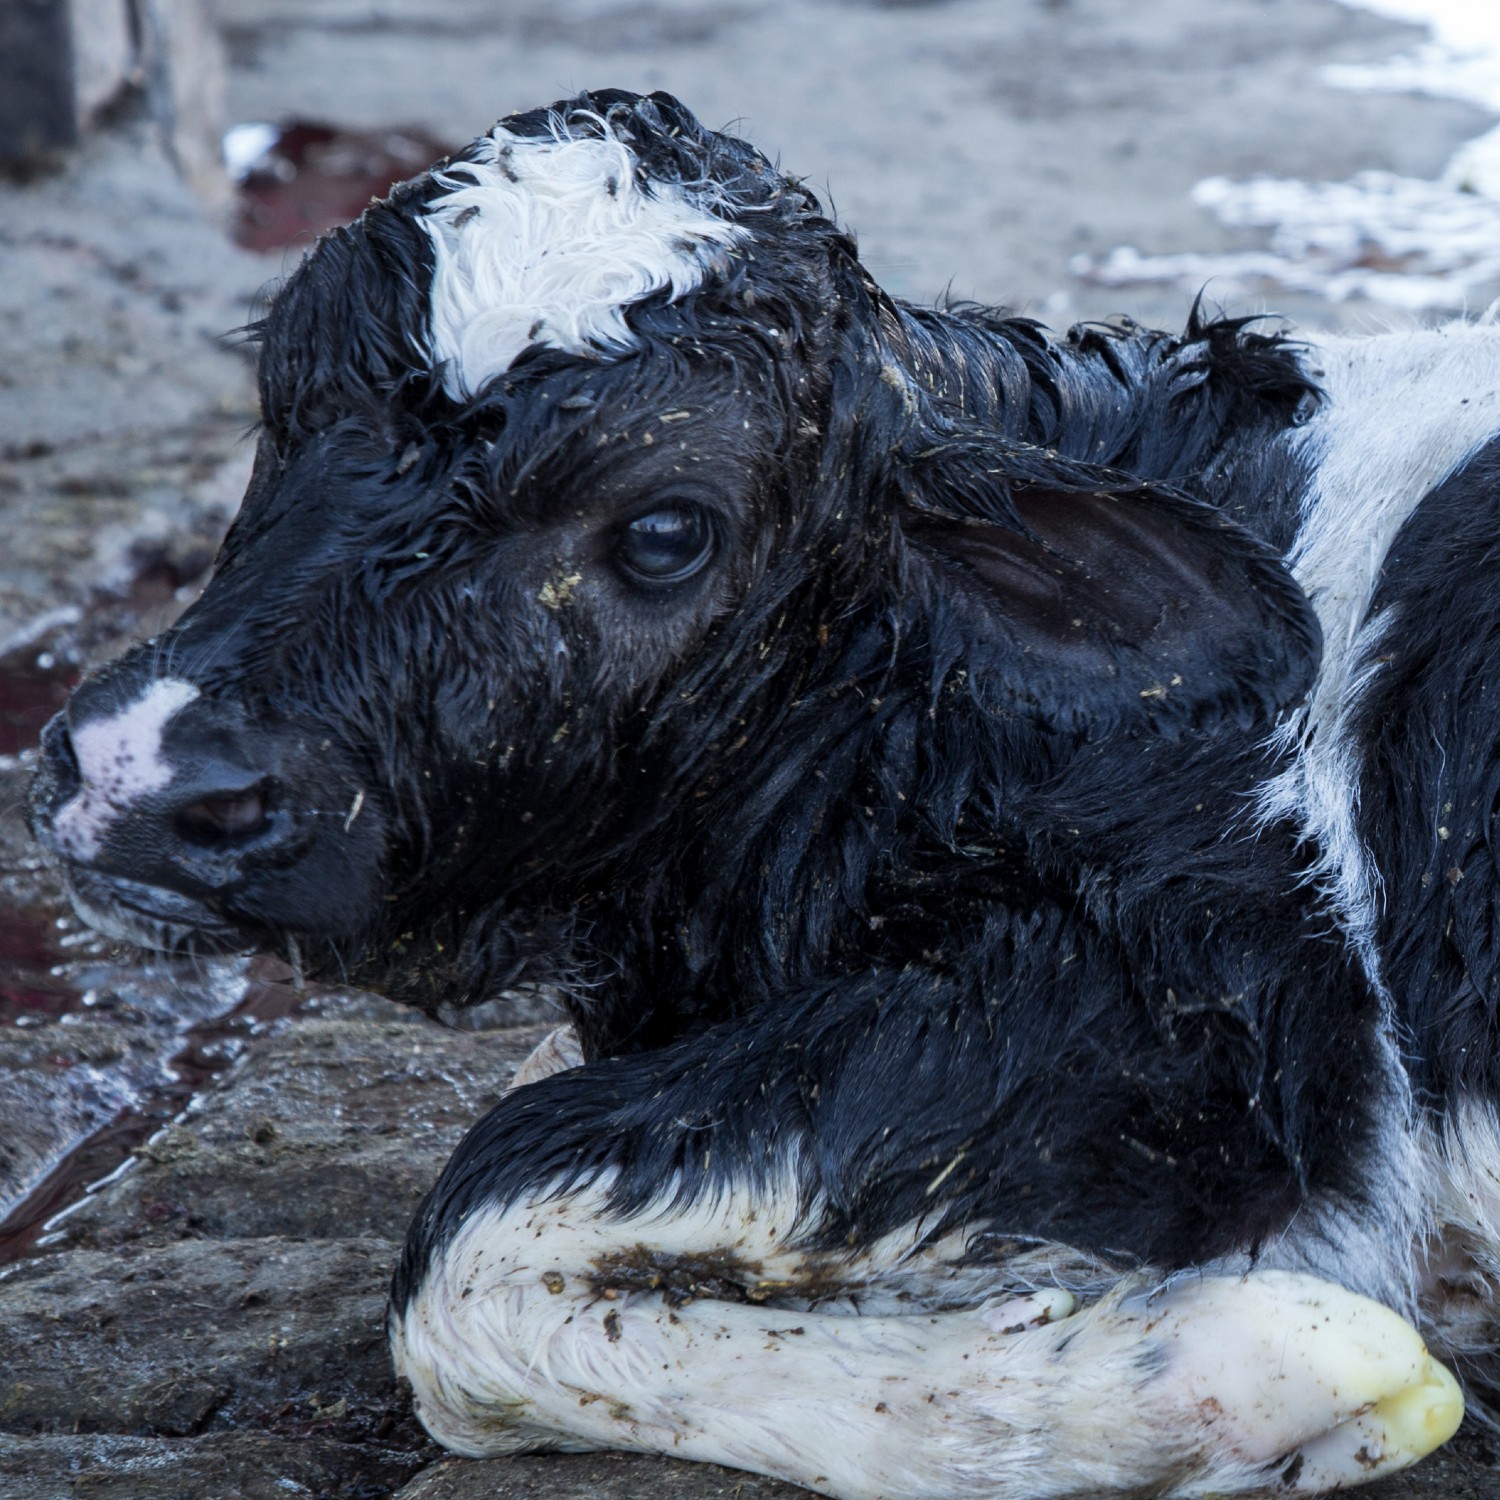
[392,1184,1463,1500]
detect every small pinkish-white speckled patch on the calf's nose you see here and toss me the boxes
[53,677,198,860]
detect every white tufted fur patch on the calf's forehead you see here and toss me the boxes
[419,122,744,401]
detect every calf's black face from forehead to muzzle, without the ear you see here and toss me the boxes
[33,96,870,1008]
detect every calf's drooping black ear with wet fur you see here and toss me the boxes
[900,483,1322,734]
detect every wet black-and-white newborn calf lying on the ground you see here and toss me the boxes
[33,93,1500,1500]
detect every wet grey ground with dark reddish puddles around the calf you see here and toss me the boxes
[0,0,1500,1500]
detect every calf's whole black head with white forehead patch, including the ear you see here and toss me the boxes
[33,93,1316,999]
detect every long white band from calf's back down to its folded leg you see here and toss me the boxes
[1260,324,1500,1344]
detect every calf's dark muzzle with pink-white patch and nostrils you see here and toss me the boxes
[32,657,381,947]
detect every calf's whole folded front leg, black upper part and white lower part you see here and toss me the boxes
[392,993,1463,1500]
